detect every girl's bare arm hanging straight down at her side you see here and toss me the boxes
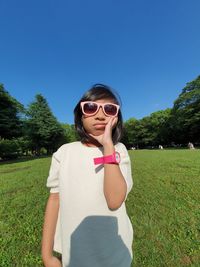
[42,193,61,267]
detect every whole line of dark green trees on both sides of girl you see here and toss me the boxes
[0,76,200,159]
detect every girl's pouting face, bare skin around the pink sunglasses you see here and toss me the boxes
[82,99,118,136]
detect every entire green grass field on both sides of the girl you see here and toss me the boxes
[0,150,200,267]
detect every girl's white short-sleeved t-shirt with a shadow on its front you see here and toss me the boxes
[47,142,133,267]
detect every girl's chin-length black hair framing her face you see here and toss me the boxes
[74,83,123,144]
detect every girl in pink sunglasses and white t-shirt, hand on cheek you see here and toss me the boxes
[42,84,133,267]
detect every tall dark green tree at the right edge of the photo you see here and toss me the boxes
[171,76,200,143]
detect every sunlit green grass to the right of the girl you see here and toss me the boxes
[127,150,200,267]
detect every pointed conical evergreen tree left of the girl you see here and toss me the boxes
[26,94,64,154]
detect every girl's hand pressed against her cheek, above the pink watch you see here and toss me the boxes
[90,117,118,146]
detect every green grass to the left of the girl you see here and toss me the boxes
[0,158,50,267]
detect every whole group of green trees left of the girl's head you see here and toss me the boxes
[0,84,77,159]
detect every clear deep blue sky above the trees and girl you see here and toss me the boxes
[0,0,200,124]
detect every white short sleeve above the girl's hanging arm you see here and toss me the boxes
[46,151,60,193]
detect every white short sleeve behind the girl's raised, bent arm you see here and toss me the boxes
[116,143,133,198]
